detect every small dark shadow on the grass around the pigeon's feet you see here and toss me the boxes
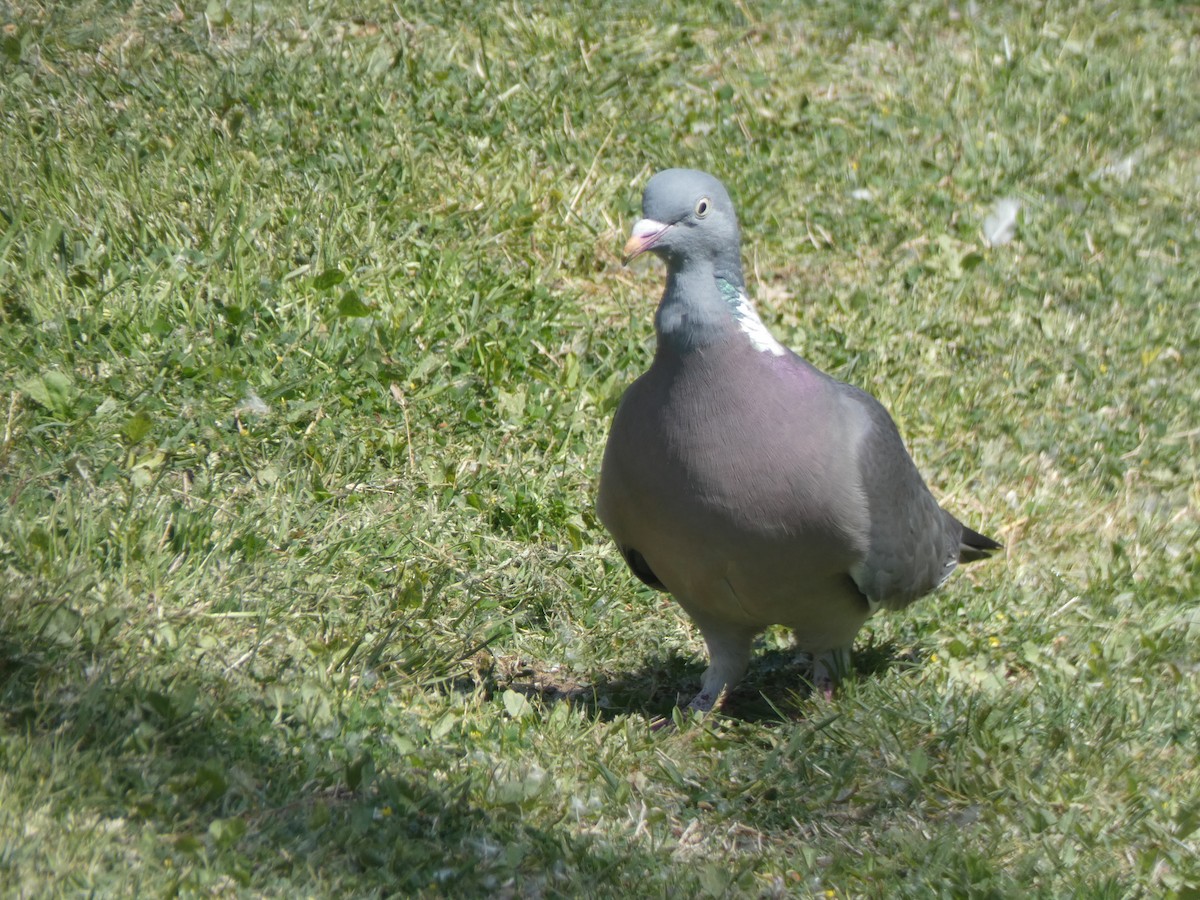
[493,641,922,722]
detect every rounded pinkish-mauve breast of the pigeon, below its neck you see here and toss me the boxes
[600,346,868,602]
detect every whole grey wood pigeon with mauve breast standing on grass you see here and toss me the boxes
[596,169,1001,712]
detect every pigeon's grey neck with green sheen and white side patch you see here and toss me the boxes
[654,264,785,356]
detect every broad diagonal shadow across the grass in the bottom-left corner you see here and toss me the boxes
[0,617,661,896]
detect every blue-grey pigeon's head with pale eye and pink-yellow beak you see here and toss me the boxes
[625,169,742,272]
